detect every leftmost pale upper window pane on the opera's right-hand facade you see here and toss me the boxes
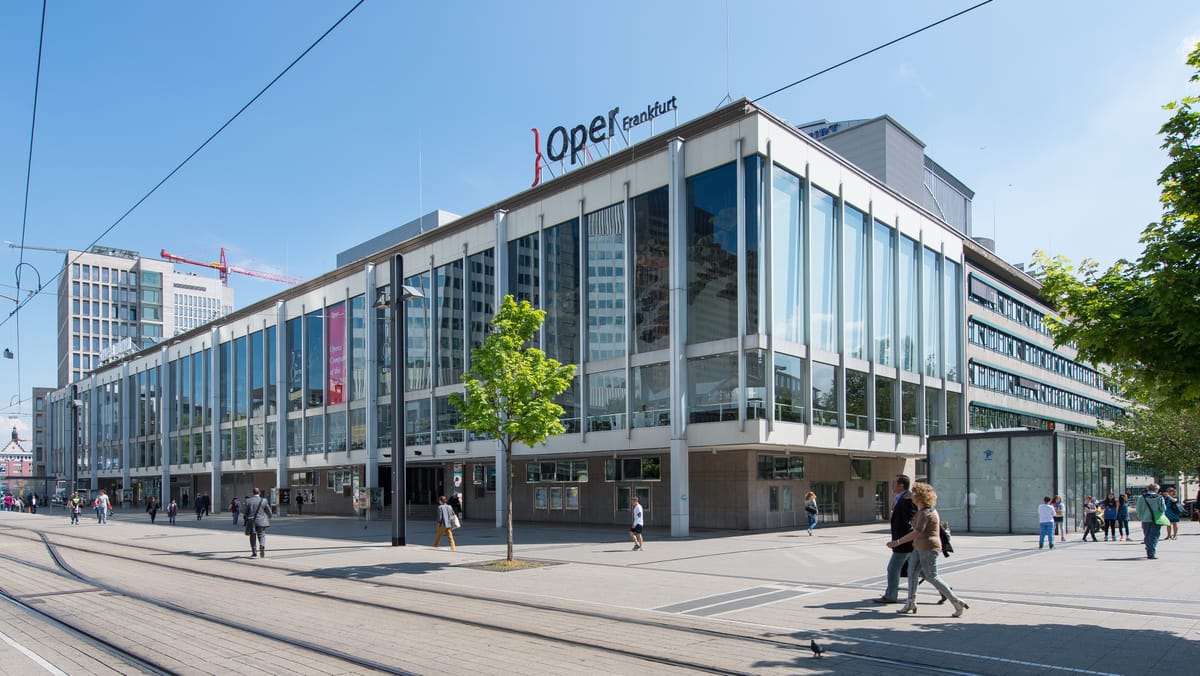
[770,167,805,343]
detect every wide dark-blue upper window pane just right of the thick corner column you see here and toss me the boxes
[685,162,739,343]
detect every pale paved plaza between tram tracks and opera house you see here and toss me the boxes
[0,510,1200,674]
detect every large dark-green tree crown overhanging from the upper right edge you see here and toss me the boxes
[1033,44,1200,409]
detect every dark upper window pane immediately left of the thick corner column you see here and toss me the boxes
[634,186,671,353]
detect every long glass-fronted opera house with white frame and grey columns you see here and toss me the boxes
[39,102,1115,534]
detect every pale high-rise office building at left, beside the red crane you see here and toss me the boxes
[58,246,233,388]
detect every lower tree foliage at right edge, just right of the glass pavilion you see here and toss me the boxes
[1096,406,1200,474]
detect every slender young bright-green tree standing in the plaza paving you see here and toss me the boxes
[450,295,575,561]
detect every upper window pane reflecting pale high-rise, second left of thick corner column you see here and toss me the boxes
[584,204,625,360]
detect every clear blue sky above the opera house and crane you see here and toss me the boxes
[0,0,1200,437]
